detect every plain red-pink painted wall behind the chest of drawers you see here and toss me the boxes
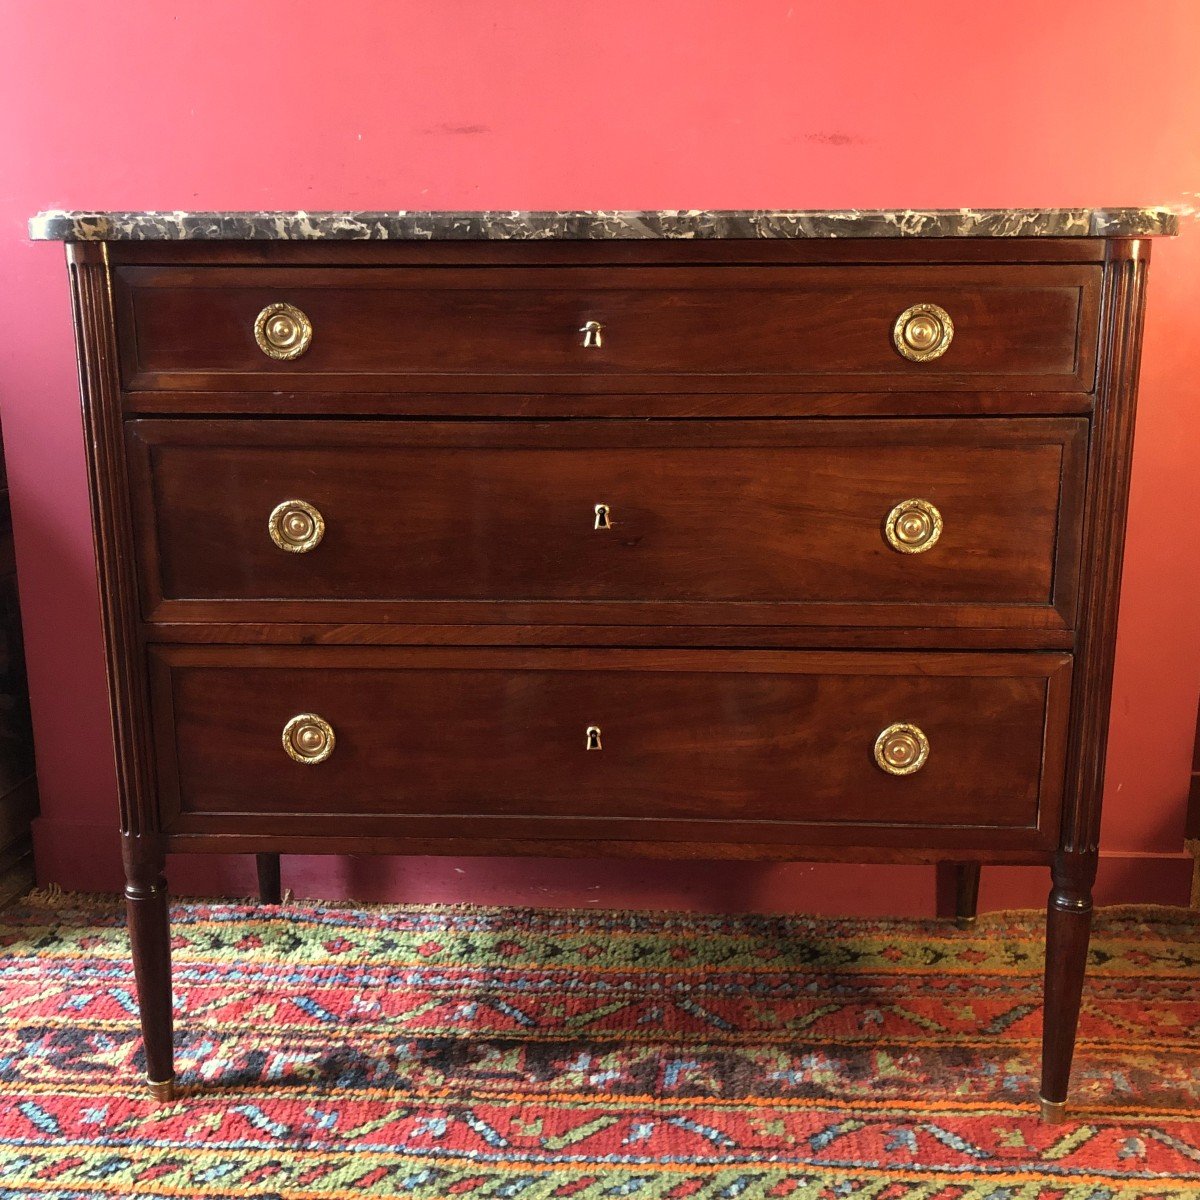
[0,0,1200,911]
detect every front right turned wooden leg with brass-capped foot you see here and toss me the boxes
[1042,854,1096,1122]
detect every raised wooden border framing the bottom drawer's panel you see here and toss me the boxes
[148,644,1073,850]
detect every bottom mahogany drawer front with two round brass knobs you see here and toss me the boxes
[151,646,1070,848]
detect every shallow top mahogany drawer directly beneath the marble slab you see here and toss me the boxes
[114,264,1100,392]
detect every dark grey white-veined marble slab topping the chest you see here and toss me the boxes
[29,208,1177,241]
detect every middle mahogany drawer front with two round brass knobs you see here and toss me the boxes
[128,419,1086,630]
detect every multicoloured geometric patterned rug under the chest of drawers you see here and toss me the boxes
[0,895,1200,1200]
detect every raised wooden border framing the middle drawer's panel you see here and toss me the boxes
[125,416,1088,631]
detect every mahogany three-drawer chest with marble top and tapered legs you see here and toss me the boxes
[35,211,1170,1120]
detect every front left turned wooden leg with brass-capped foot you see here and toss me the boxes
[125,836,175,1100]
